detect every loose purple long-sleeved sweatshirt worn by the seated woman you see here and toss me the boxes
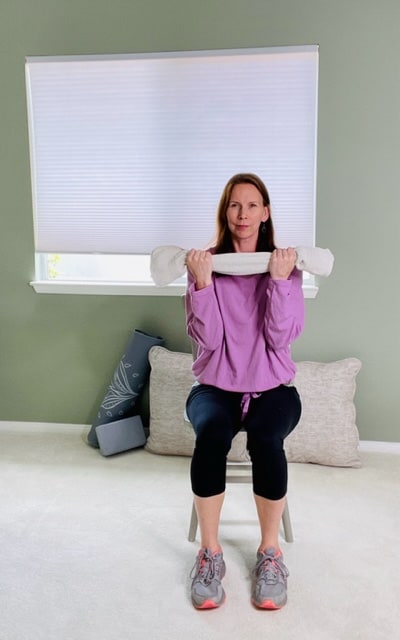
[186,269,304,393]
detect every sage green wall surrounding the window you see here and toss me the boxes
[0,0,400,441]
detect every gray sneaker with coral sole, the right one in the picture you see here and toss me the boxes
[251,548,289,609]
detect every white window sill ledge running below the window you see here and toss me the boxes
[29,280,318,298]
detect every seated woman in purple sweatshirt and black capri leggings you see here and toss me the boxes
[186,173,304,609]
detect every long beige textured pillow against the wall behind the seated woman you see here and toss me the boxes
[145,346,361,467]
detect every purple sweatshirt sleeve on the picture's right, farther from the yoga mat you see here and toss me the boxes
[264,269,305,350]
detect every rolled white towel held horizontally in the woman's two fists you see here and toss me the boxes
[150,245,334,287]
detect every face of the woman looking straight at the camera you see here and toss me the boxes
[226,184,269,251]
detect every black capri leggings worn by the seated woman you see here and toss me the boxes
[186,384,301,500]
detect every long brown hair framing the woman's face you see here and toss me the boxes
[215,173,276,253]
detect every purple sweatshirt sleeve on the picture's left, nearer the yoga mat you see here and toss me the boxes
[185,273,223,351]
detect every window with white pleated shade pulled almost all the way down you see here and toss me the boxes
[26,46,318,295]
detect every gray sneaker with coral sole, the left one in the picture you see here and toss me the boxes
[190,549,225,609]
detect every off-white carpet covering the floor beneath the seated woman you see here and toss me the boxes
[0,422,400,640]
